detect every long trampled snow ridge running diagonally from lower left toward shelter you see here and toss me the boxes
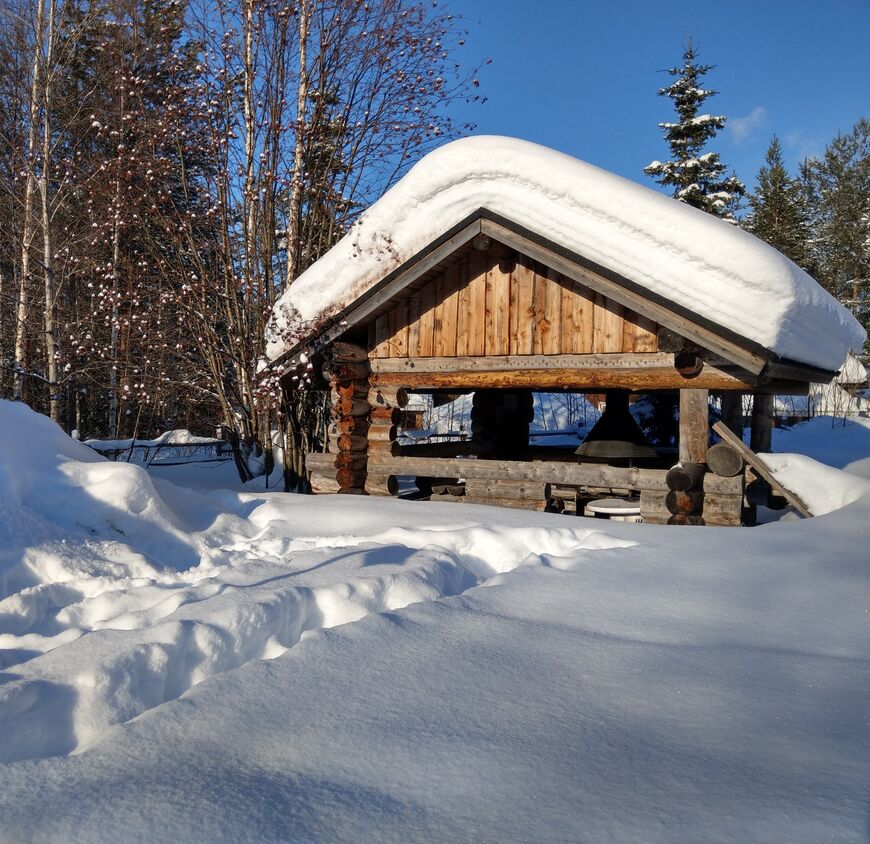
[0,526,634,762]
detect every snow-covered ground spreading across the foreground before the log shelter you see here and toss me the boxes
[0,403,870,842]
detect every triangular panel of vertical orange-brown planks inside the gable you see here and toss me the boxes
[369,250,658,358]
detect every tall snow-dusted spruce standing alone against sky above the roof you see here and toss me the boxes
[644,42,746,222]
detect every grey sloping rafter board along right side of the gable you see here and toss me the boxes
[481,218,767,375]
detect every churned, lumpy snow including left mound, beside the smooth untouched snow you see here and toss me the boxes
[0,402,633,761]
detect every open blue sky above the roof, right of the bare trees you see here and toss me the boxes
[449,0,870,193]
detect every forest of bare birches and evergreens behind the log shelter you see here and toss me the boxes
[0,0,870,474]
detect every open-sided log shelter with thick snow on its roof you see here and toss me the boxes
[268,137,864,524]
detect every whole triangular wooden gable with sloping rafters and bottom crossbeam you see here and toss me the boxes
[312,214,807,394]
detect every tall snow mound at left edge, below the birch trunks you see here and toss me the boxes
[0,401,208,598]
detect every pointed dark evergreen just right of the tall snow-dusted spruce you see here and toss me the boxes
[745,135,812,270]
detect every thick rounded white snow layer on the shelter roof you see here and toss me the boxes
[267,136,865,370]
